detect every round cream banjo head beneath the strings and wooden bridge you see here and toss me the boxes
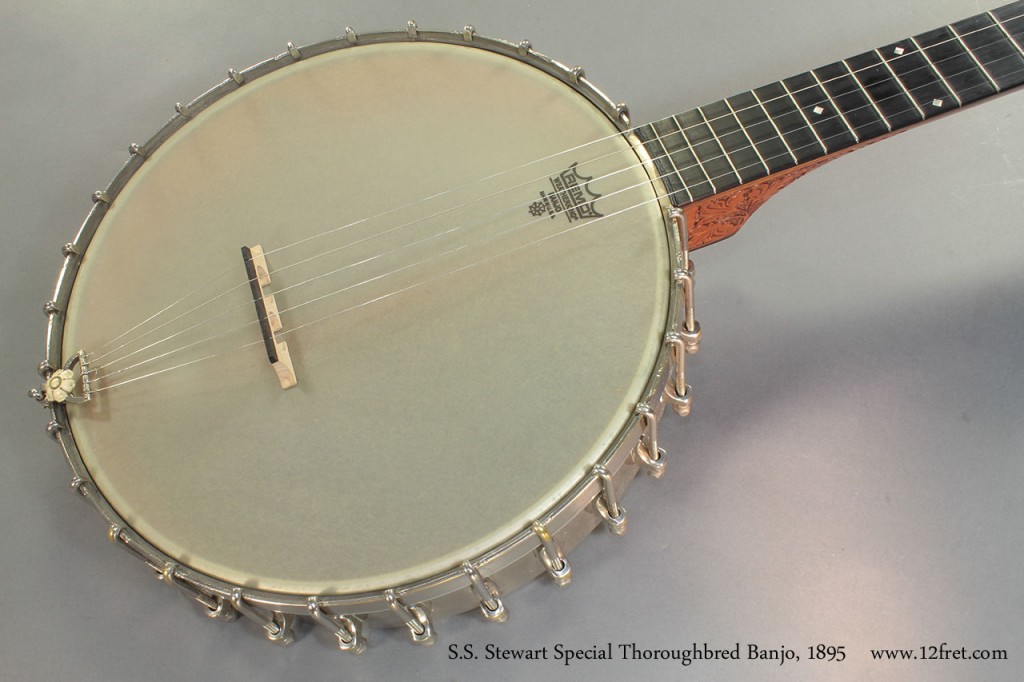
[63,42,672,594]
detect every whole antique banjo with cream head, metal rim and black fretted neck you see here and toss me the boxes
[32,2,1024,652]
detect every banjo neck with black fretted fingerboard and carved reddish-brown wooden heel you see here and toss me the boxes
[636,0,1024,249]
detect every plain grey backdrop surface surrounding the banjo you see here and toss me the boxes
[0,0,1024,680]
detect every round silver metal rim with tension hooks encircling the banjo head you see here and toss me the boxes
[39,22,688,630]
